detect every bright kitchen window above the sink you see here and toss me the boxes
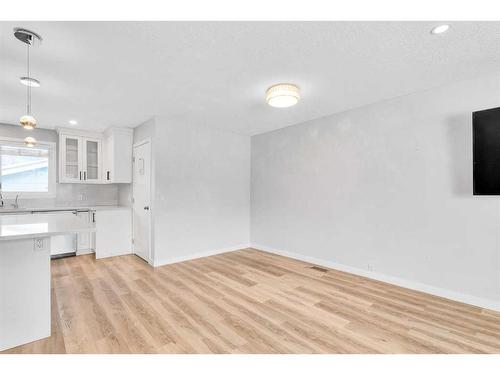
[0,138,56,198]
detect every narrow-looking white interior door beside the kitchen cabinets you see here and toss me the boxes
[132,141,151,262]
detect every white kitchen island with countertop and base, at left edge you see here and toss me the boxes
[0,214,95,351]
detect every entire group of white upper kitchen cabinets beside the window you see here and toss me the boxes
[58,128,133,184]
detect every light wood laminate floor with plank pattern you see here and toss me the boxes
[0,249,500,353]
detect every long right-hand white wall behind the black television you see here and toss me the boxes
[251,75,500,308]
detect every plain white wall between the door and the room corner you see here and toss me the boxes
[148,117,250,265]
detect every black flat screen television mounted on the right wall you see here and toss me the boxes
[472,107,500,195]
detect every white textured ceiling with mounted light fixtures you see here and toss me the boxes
[0,22,500,135]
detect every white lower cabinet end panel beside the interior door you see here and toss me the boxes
[91,208,132,259]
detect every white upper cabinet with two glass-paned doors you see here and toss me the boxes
[59,129,103,184]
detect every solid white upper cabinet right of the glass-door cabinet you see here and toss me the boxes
[103,128,134,184]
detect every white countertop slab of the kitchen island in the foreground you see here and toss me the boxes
[0,214,95,241]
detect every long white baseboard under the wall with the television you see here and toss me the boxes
[250,244,500,312]
